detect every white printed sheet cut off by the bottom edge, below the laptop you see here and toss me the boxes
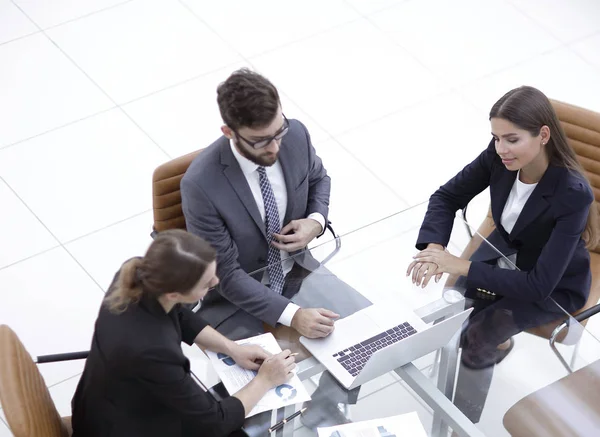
[317,412,427,437]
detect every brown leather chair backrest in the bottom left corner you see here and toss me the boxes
[0,325,69,437]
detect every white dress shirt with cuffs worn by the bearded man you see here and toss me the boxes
[229,140,325,326]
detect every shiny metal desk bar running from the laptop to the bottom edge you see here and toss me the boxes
[396,362,485,437]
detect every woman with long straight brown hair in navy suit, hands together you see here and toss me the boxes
[407,86,598,422]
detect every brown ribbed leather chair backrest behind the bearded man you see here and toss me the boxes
[152,150,202,232]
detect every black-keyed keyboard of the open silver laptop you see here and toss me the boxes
[333,322,417,376]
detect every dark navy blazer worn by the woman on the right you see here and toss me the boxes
[417,140,594,312]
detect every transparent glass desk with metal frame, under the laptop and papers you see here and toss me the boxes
[203,203,600,437]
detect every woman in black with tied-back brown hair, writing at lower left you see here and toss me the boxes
[72,230,295,437]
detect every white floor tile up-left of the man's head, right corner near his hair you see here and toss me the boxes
[47,0,239,104]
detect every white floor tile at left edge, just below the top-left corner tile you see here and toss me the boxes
[0,32,113,148]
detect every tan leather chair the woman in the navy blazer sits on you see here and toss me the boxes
[461,100,600,343]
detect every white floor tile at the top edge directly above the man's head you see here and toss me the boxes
[184,0,360,57]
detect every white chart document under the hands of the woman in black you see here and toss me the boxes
[206,333,310,417]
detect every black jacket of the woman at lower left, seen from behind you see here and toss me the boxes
[72,262,244,437]
